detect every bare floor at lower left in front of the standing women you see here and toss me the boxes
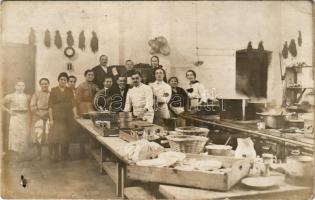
[1,146,116,199]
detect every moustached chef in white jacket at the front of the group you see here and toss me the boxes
[124,72,154,123]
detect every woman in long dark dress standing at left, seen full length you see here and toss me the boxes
[48,72,78,161]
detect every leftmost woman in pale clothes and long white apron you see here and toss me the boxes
[3,81,30,153]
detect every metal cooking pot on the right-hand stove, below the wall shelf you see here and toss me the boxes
[257,113,285,129]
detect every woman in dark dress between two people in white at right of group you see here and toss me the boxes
[168,77,188,116]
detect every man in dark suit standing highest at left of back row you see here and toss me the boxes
[92,55,118,88]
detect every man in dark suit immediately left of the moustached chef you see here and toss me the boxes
[111,76,129,112]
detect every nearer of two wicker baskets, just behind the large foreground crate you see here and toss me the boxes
[166,135,208,153]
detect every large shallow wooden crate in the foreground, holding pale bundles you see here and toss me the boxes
[127,154,251,191]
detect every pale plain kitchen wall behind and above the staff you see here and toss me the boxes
[3,1,312,102]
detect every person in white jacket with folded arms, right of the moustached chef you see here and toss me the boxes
[150,68,172,125]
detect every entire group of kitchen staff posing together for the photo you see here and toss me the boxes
[2,55,208,161]
